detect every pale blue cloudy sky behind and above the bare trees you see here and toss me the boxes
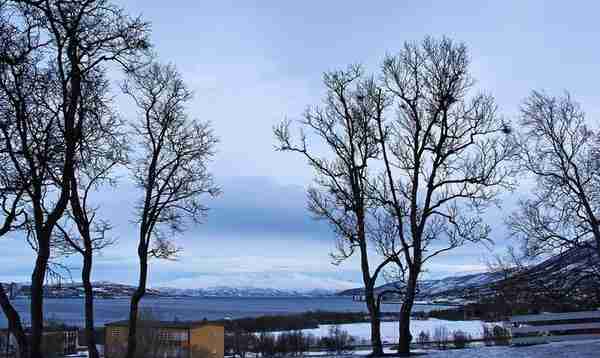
[0,0,600,288]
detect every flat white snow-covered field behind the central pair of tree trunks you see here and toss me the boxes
[303,318,483,343]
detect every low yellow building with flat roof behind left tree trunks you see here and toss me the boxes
[104,320,225,358]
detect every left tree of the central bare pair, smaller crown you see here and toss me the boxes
[274,66,390,355]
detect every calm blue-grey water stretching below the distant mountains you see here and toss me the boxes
[0,297,439,327]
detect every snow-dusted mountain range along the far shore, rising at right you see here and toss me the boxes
[7,249,600,300]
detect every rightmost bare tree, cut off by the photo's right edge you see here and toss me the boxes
[508,91,600,281]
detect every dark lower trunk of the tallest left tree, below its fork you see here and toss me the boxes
[29,241,50,358]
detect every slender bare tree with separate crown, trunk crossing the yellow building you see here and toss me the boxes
[123,63,219,358]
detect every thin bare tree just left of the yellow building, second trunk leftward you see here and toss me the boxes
[58,67,127,358]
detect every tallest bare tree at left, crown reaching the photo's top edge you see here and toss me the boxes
[1,0,148,357]
